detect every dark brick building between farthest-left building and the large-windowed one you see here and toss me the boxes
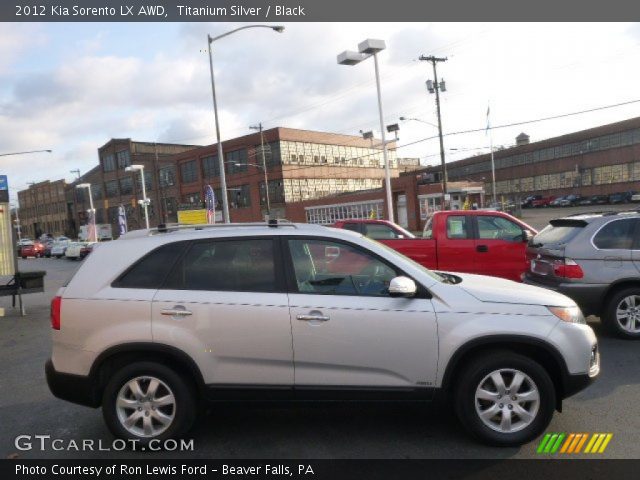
[66,138,197,236]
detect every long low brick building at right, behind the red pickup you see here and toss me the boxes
[422,117,640,200]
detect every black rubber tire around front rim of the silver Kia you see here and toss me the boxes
[454,351,556,447]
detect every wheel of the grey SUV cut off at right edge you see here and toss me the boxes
[602,286,640,339]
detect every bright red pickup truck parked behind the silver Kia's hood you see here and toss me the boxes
[333,210,538,282]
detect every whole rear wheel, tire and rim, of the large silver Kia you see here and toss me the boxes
[102,362,197,444]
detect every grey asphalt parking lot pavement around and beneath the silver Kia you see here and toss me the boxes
[0,256,640,459]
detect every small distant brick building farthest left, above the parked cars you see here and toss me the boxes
[18,180,69,239]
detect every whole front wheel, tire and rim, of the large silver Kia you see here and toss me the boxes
[455,351,556,447]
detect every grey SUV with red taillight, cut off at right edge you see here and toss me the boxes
[524,212,640,339]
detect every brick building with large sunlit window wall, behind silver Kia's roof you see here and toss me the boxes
[176,127,399,222]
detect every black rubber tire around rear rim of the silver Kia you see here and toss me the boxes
[102,362,198,444]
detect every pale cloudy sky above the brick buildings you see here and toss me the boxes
[0,23,640,204]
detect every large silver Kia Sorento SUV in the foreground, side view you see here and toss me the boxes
[46,222,600,445]
